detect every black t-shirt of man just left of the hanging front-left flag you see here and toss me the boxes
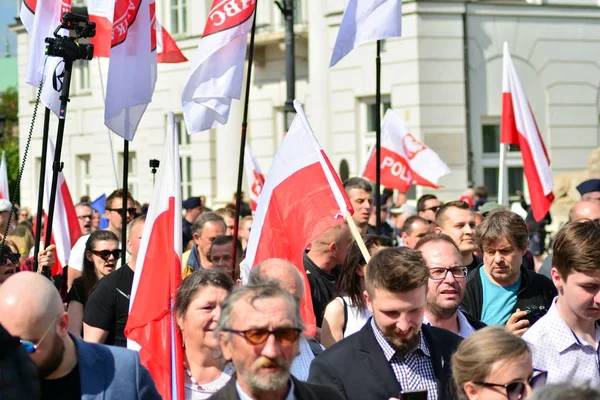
[83,266,133,347]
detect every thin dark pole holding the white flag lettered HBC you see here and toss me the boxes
[231,7,258,271]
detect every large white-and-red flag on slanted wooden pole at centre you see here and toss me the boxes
[243,100,353,336]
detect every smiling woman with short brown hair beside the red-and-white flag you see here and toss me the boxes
[175,269,235,400]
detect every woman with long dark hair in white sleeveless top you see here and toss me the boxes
[321,235,393,347]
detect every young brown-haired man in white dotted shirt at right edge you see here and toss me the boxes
[523,220,600,387]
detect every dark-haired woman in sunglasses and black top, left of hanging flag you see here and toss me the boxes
[67,231,121,337]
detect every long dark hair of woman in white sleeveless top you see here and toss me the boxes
[334,235,393,310]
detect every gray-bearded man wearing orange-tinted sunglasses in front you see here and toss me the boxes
[211,282,342,400]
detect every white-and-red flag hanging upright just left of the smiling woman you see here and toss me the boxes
[125,113,184,400]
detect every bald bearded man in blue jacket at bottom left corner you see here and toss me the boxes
[0,272,160,400]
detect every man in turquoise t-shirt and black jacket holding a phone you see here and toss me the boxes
[462,210,556,336]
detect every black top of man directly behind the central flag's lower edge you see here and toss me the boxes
[304,255,340,328]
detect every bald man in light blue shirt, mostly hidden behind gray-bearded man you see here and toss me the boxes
[248,258,323,381]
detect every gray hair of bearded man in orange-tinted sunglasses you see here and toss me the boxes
[215,281,304,334]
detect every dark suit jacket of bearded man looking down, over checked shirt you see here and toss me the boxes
[308,320,462,400]
